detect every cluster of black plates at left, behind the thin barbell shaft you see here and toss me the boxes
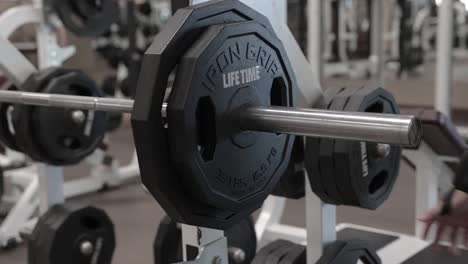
[13,68,107,166]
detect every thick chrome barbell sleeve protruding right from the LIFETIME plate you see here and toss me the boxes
[240,107,422,146]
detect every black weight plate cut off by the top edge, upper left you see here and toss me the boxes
[51,0,119,37]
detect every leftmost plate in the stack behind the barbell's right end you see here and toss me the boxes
[305,87,345,204]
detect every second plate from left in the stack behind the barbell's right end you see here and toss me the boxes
[319,88,359,205]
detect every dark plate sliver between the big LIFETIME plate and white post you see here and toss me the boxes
[272,137,305,199]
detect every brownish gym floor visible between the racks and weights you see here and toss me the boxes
[0,69,468,264]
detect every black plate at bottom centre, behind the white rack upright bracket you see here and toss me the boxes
[153,216,257,264]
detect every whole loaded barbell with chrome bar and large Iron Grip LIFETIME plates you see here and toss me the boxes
[0,0,421,230]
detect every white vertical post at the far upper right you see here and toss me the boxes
[434,0,453,117]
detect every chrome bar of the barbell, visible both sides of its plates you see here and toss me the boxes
[0,90,422,147]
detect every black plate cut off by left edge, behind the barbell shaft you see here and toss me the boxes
[0,85,20,151]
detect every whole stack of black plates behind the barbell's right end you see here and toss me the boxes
[306,87,401,209]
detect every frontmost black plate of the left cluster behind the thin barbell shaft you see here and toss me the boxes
[32,70,107,165]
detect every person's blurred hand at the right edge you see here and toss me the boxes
[419,190,468,254]
